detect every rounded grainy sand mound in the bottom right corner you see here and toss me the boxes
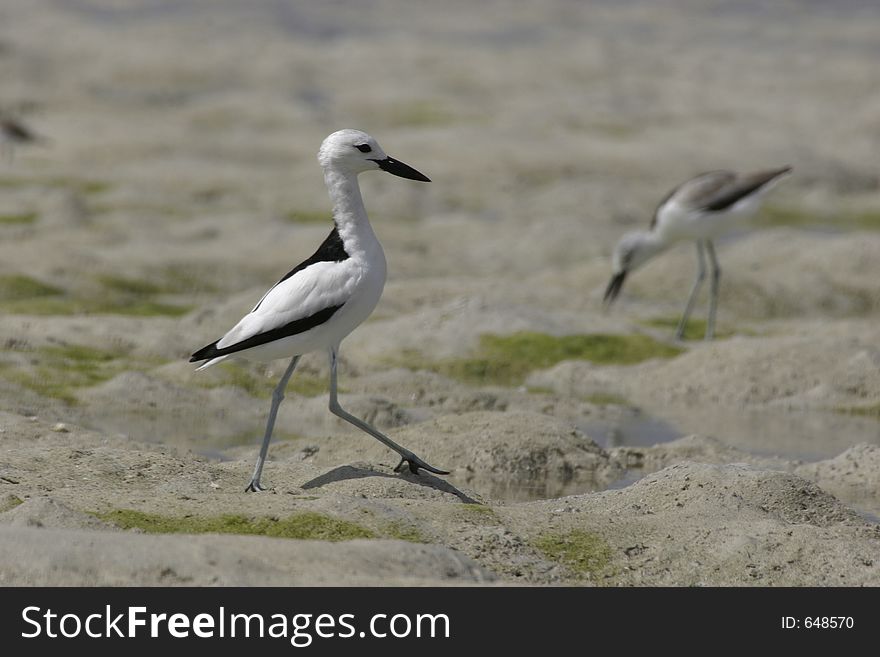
[511,463,880,586]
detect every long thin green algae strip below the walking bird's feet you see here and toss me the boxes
[94,509,376,542]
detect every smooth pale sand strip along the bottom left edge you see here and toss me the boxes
[0,527,495,586]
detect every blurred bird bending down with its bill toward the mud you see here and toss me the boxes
[604,166,791,340]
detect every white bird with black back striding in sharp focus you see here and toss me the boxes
[190,130,449,491]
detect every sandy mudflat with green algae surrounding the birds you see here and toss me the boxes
[0,0,880,586]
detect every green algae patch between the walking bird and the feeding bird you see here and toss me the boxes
[394,331,682,386]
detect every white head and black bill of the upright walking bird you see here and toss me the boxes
[318,128,431,182]
